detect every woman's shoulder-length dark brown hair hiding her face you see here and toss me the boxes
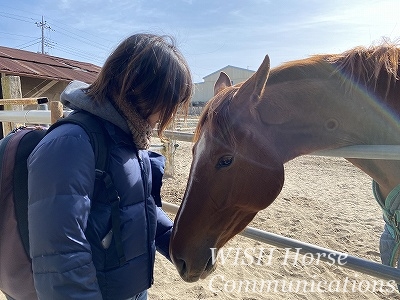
[86,34,193,136]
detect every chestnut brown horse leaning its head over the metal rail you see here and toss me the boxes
[170,42,400,282]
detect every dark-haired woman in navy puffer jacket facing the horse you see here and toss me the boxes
[28,34,192,300]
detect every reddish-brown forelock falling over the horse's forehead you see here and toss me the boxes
[193,87,238,143]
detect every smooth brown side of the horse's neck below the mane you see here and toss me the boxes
[259,79,400,162]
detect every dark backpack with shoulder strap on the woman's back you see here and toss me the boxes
[0,111,125,299]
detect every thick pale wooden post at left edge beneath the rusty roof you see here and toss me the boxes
[1,75,23,137]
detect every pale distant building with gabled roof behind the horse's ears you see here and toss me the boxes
[192,65,255,106]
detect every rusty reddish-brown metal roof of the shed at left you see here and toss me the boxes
[0,46,101,84]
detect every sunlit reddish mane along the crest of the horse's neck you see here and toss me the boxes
[268,41,400,97]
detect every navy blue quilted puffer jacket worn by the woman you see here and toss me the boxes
[28,116,172,300]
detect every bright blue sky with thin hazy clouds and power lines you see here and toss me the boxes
[0,0,400,82]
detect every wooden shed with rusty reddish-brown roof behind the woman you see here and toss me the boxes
[0,46,100,138]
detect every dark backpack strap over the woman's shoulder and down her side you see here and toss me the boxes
[47,111,126,266]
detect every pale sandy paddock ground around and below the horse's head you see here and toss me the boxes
[0,142,400,300]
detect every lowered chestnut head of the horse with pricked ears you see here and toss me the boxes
[170,56,284,282]
